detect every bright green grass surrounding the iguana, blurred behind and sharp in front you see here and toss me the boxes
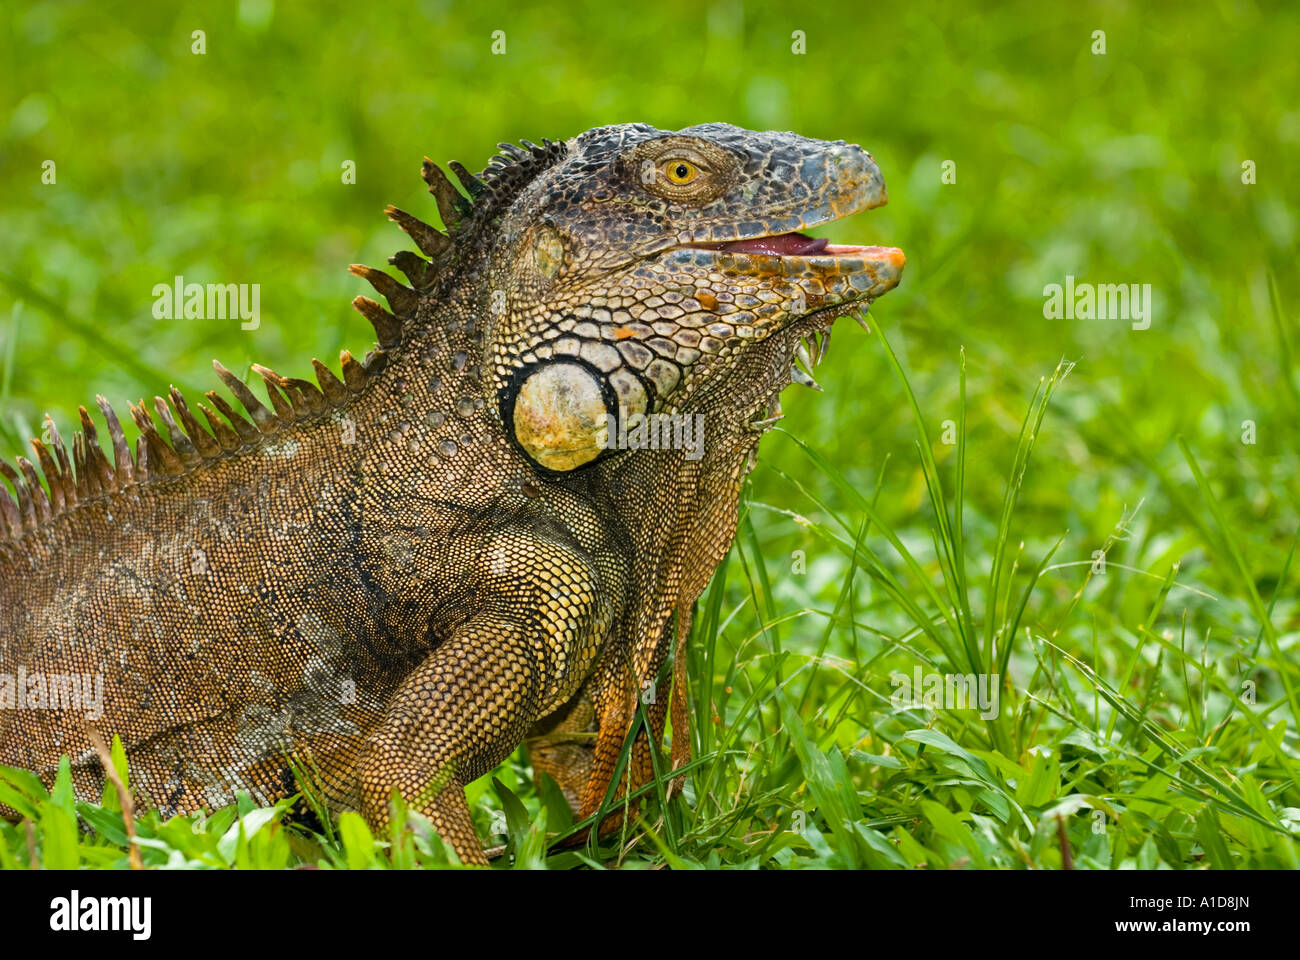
[0,3,1300,869]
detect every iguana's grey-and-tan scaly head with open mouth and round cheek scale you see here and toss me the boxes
[486,124,904,471]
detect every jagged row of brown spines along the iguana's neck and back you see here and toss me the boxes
[0,139,568,550]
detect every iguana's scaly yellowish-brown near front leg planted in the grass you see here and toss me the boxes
[359,531,611,864]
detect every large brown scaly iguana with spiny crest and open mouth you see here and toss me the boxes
[0,124,904,864]
